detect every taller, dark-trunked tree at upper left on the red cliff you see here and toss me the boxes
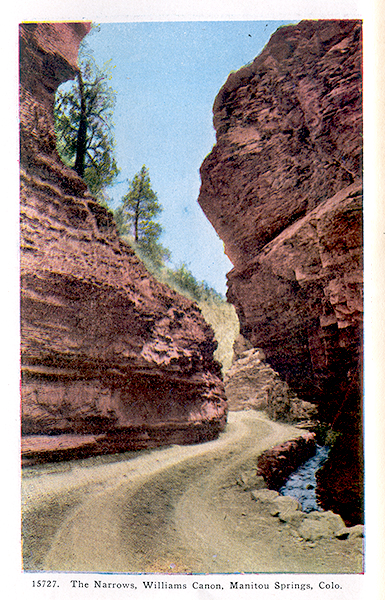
[54,46,118,195]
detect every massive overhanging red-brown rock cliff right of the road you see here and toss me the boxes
[199,20,363,524]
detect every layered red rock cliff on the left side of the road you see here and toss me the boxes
[20,23,227,461]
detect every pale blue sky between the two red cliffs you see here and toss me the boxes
[80,21,289,294]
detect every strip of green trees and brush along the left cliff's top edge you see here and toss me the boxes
[54,44,239,371]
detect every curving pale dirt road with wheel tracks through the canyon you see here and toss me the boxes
[23,411,362,573]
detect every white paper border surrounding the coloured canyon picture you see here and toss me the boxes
[4,0,385,600]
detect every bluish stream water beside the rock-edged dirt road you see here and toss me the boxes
[279,445,329,512]
